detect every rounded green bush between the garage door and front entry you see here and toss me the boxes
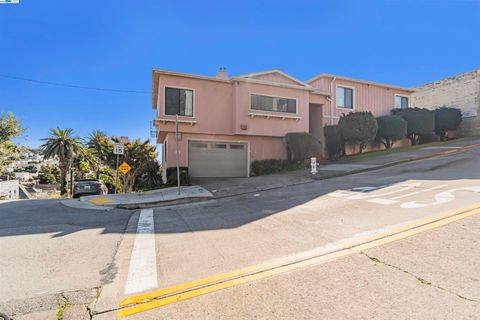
[285,132,322,162]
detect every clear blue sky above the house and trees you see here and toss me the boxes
[0,0,480,147]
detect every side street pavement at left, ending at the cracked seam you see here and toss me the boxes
[0,200,131,314]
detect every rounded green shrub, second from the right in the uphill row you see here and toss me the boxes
[392,108,435,145]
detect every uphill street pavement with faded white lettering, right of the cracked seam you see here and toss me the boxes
[94,149,480,319]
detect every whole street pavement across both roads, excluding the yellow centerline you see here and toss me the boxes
[0,149,480,319]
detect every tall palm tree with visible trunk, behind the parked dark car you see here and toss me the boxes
[41,127,82,195]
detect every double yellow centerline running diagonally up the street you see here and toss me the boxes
[117,204,480,318]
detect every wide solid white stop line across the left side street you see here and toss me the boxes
[125,209,158,294]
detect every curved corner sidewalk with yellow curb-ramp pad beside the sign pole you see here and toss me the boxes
[79,186,213,209]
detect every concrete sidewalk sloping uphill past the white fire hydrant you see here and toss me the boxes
[194,137,480,198]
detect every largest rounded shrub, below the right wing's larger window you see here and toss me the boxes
[338,111,378,153]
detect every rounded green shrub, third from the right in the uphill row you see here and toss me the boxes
[376,116,407,149]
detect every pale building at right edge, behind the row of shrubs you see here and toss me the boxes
[412,69,480,135]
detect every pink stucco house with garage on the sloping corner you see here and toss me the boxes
[152,69,413,177]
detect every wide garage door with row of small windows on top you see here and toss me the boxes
[188,141,248,177]
